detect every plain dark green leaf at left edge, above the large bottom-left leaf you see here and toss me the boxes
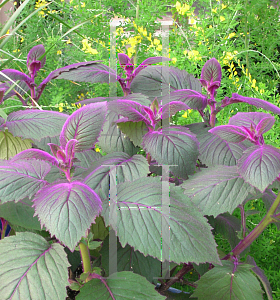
[0,197,41,230]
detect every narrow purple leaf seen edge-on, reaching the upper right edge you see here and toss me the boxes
[224,93,280,115]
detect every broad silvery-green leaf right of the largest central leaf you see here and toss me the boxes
[181,166,254,217]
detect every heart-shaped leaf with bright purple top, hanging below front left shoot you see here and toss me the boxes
[33,182,102,251]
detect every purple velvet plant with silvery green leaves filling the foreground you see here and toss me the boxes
[0,45,280,299]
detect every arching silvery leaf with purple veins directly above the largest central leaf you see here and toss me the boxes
[82,152,149,202]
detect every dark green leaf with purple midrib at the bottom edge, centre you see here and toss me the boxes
[76,271,165,300]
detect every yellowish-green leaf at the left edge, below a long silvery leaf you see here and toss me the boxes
[0,130,32,159]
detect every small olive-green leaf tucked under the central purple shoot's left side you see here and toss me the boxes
[117,121,148,147]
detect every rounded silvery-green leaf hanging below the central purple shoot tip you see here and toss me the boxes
[142,126,199,179]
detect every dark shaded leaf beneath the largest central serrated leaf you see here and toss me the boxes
[100,231,161,282]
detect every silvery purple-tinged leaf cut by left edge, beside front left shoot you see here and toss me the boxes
[0,159,51,203]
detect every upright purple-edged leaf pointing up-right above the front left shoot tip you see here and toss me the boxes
[60,102,107,152]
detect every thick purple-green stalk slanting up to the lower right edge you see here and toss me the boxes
[223,192,280,260]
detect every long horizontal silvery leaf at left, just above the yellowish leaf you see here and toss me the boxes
[2,109,69,141]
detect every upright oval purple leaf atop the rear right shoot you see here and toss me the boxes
[200,58,222,95]
